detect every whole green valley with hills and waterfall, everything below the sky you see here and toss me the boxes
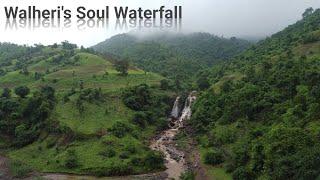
[0,8,320,180]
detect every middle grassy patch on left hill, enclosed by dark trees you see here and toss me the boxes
[54,97,133,134]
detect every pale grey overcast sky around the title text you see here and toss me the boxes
[0,0,320,47]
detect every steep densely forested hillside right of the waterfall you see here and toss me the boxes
[189,9,320,180]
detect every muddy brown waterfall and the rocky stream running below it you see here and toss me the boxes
[150,92,196,179]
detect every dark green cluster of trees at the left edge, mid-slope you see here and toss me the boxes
[0,86,55,146]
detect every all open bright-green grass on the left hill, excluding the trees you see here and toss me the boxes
[0,49,166,173]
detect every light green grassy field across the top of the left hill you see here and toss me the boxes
[0,53,163,92]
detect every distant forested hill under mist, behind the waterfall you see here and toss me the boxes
[93,33,251,87]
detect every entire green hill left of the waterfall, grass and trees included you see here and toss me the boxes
[0,42,174,177]
